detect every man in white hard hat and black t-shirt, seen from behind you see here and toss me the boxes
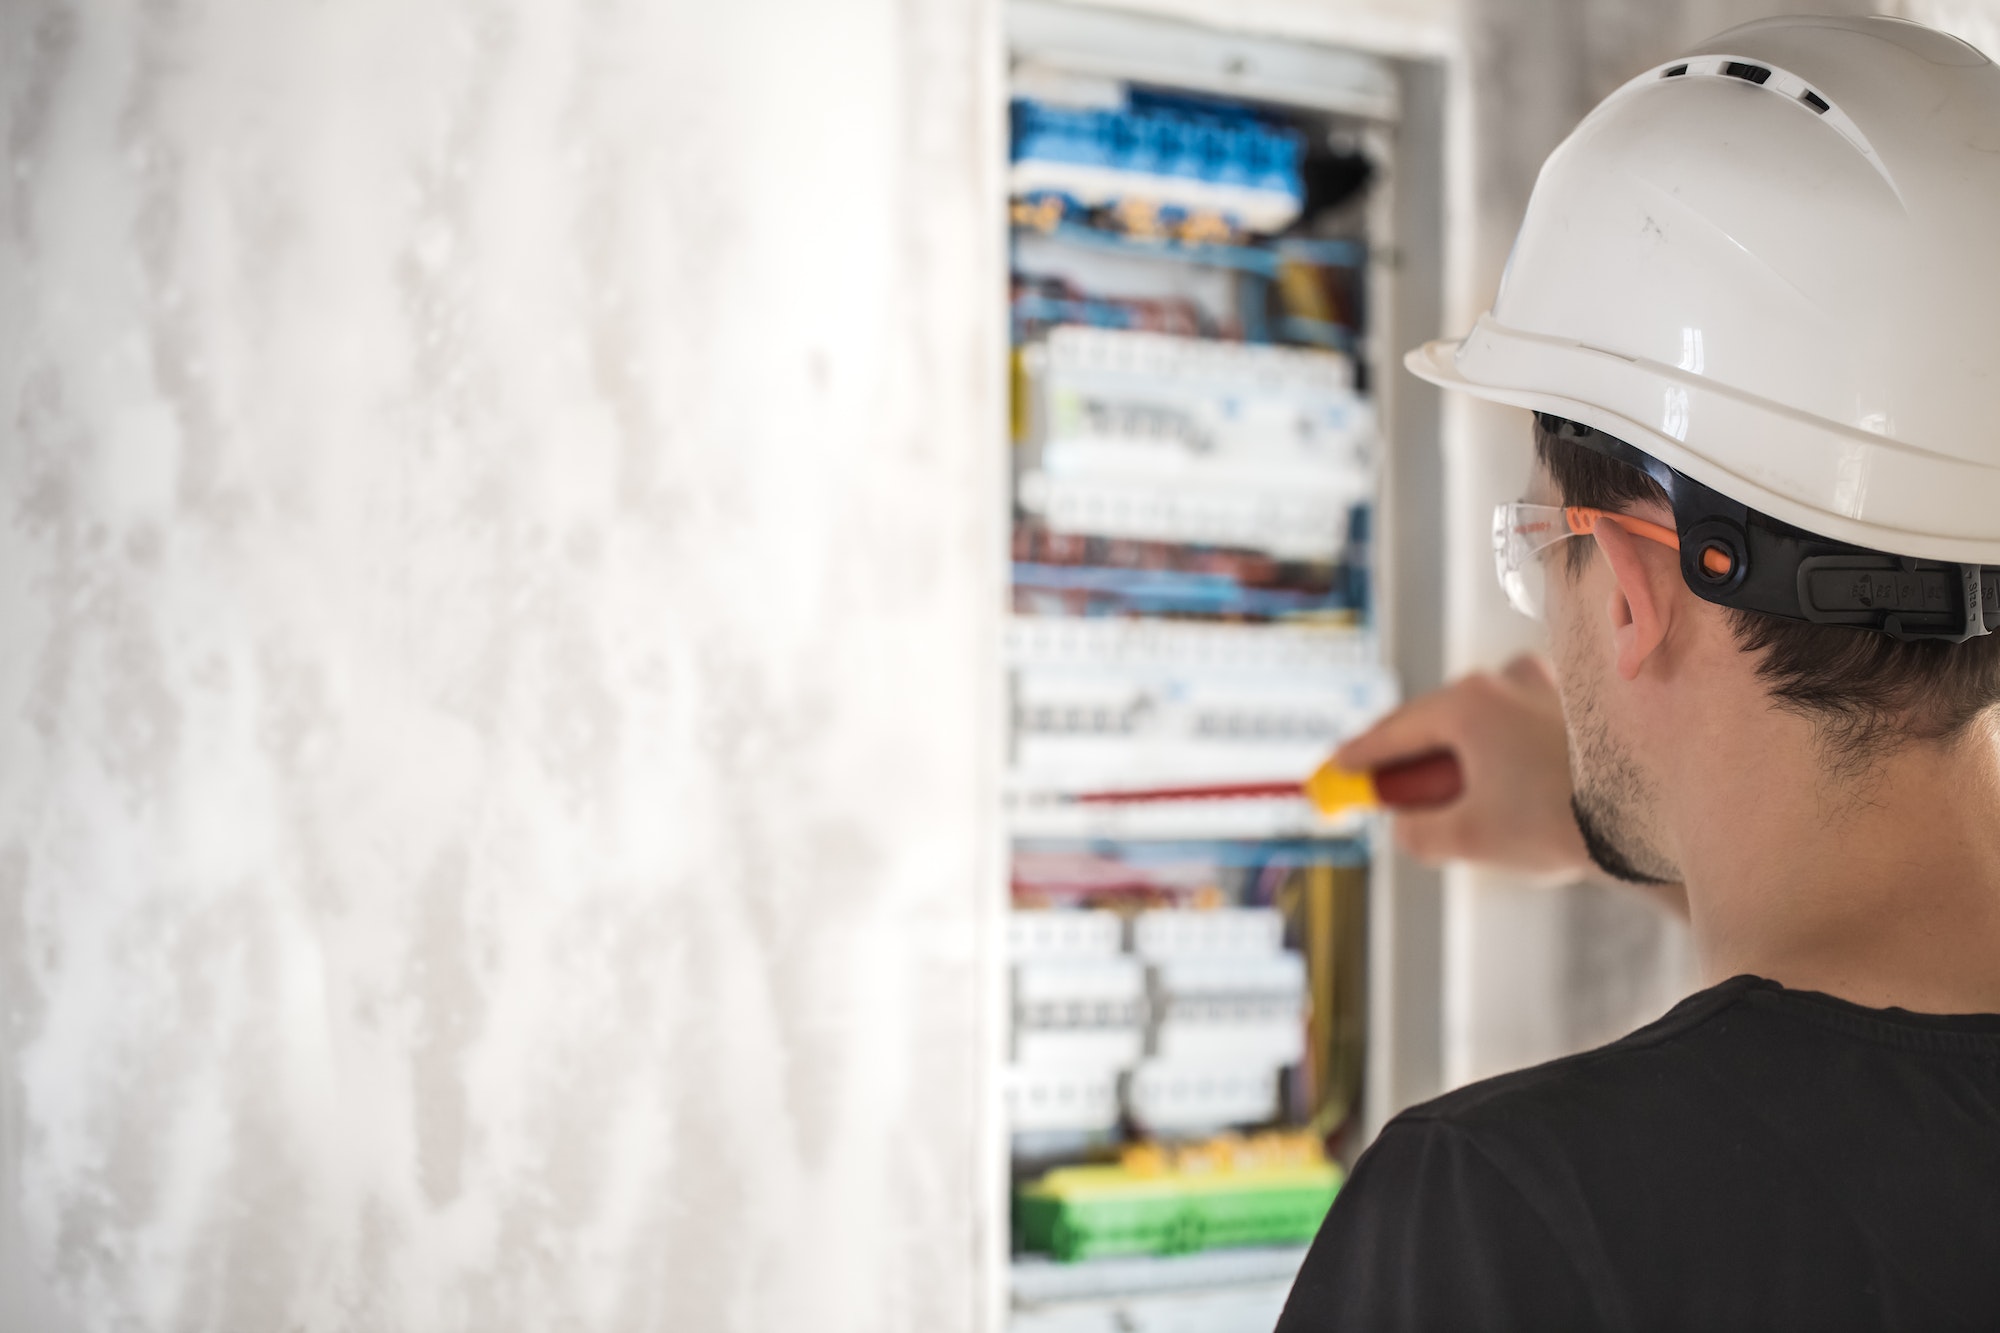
[1280,18,2000,1333]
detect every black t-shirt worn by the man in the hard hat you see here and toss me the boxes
[1278,961,2000,1333]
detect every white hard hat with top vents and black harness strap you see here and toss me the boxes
[1406,18,2000,638]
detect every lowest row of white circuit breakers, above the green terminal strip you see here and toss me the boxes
[1006,909,1306,1135]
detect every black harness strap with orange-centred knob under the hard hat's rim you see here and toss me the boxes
[1538,412,2000,642]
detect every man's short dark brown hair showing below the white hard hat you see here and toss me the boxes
[1534,416,2000,765]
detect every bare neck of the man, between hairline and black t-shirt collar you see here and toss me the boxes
[1672,715,2000,1013]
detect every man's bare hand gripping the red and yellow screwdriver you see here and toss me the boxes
[1334,656,1594,877]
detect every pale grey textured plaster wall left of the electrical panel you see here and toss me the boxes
[0,0,1004,1333]
